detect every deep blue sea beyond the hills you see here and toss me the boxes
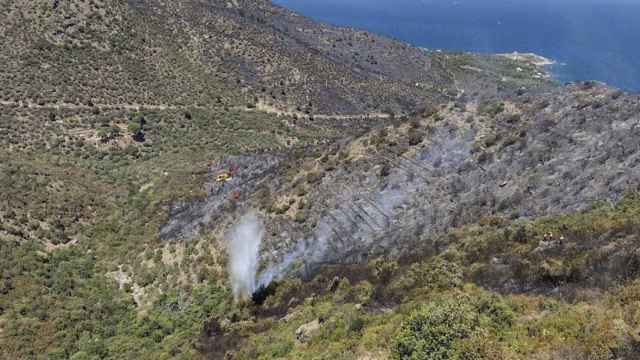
[275,0,640,92]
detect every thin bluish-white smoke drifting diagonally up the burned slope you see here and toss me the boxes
[257,129,475,287]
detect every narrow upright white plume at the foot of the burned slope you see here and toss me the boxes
[229,212,264,300]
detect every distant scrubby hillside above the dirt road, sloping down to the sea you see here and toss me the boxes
[2,0,552,115]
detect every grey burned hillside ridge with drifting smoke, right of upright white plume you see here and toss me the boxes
[159,80,640,286]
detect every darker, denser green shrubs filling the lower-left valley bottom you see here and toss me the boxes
[0,241,230,359]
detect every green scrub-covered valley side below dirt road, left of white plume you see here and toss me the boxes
[0,101,331,359]
